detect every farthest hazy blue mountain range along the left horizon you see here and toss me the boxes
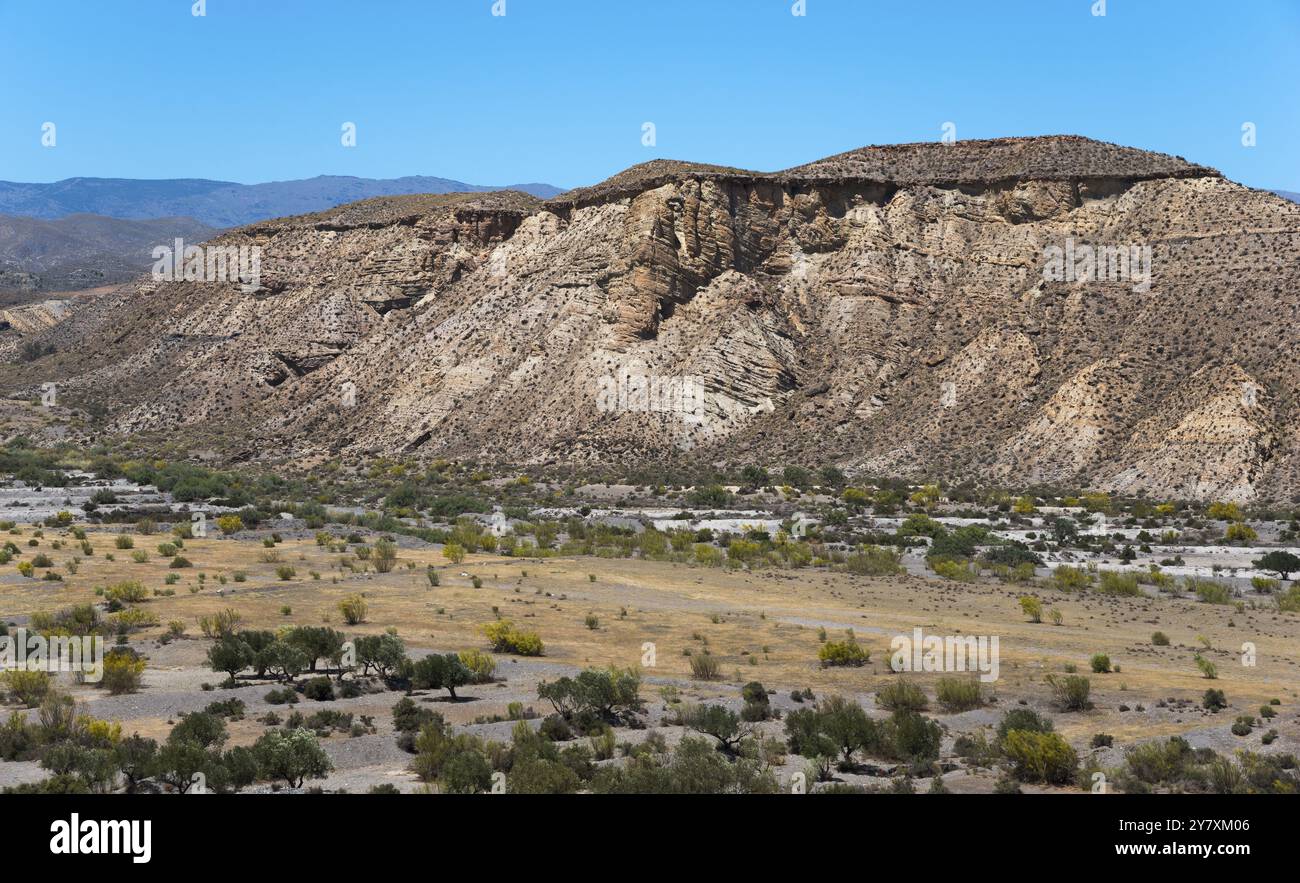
[0,174,564,228]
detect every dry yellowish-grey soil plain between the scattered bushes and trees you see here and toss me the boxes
[0,521,1300,792]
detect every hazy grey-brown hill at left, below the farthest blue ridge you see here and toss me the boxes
[0,215,217,293]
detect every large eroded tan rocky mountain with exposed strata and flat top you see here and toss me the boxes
[0,137,1300,501]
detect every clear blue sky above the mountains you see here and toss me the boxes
[0,0,1300,190]
